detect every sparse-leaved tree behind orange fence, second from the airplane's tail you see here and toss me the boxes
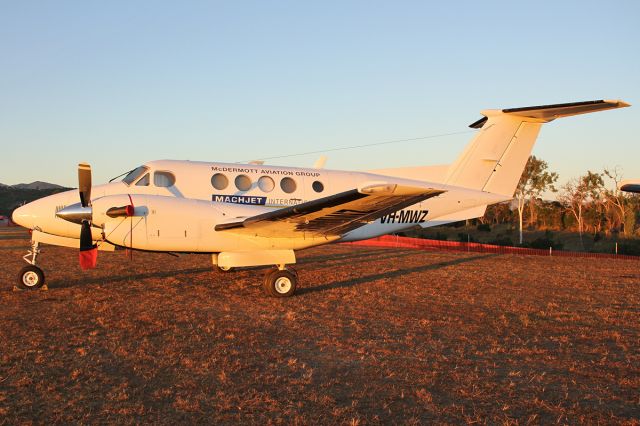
[558,171,604,249]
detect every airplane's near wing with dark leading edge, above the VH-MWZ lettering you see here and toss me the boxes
[215,183,445,238]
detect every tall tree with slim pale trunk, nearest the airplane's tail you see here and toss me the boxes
[515,155,558,244]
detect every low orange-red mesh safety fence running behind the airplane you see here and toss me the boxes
[344,235,640,260]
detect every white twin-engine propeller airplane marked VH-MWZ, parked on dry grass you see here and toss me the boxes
[13,100,629,297]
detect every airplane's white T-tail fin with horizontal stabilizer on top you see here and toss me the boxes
[446,100,630,197]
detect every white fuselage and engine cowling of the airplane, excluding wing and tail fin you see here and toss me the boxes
[14,160,506,253]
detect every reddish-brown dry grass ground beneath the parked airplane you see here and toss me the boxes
[0,228,640,425]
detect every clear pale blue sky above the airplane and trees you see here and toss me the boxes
[0,1,640,186]
